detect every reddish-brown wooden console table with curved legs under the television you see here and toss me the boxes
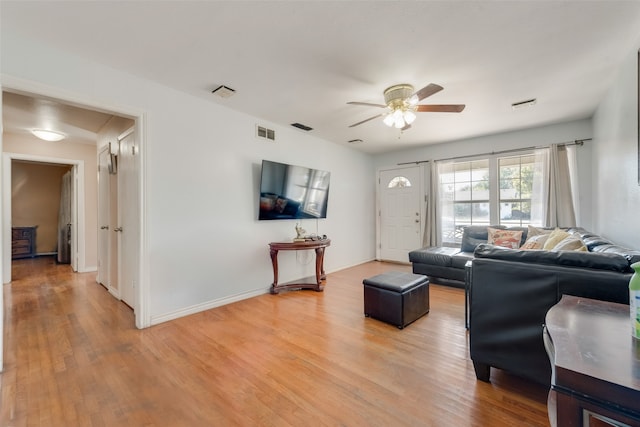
[269,239,331,294]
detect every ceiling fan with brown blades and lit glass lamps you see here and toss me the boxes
[347,83,465,130]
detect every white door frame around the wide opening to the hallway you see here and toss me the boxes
[0,74,151,372]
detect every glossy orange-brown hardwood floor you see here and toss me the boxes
[0,258,549,427]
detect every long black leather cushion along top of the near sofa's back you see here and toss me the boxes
[474,244,631,273]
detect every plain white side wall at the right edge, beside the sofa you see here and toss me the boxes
[592,44,640,250]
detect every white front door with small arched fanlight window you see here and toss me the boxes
[378,166,422,263]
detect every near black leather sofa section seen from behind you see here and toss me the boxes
[469,230,640,385]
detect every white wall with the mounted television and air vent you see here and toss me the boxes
[1,30,375,323]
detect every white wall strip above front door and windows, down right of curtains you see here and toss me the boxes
[374,119,593,230]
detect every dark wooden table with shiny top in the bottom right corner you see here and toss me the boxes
[544,295,640,427]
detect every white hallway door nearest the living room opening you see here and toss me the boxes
[117,128,140,311]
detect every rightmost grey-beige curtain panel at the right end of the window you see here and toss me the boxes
[544,144,576,227]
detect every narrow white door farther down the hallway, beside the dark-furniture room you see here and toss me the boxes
[96,147,111,289]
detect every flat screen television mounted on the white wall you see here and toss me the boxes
[258,160,331,220]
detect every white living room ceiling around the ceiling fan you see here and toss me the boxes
[0,0,640,153]
